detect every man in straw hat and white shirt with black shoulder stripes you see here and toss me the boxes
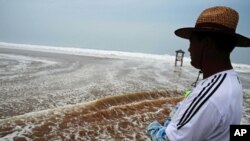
[147,6,250,141]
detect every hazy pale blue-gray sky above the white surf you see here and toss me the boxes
[0,0,250,64]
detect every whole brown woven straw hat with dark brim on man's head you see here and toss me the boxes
[175,6,250,47]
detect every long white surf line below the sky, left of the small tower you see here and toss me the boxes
[0,42,174,62]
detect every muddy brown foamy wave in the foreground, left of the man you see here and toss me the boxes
[0,91,183,140]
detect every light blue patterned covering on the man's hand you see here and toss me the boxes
[147,121,167,141]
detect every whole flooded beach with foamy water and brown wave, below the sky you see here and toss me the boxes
[0,43,250,140]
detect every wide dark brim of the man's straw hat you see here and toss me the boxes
[175,27,250,47]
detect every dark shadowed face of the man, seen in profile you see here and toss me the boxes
[188,35,203,69]
